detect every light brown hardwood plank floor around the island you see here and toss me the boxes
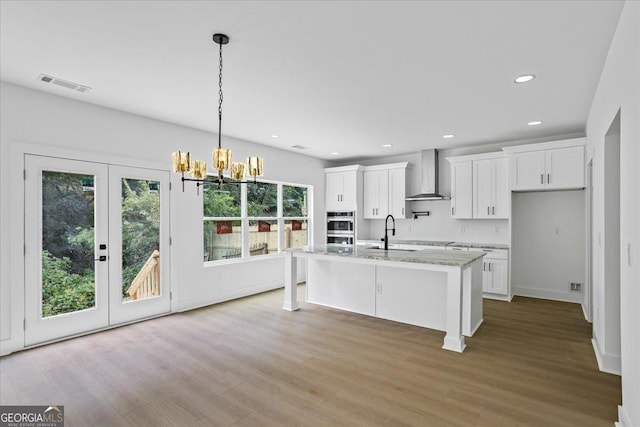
[0,287,621,427]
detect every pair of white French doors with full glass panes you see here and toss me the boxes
[25,155,170,346]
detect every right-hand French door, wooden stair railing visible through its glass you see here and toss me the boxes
[109,166,171,325]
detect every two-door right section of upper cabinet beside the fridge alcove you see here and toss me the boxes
[473,157,509,218]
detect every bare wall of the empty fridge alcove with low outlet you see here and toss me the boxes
[511,190,585,303]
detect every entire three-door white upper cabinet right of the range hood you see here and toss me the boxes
[447,152,510,219]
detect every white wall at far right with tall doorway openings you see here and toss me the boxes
[586,1,640,427]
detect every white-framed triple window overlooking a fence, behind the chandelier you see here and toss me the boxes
[203,181,310,262]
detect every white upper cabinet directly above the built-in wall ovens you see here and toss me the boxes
[325,165,363,210]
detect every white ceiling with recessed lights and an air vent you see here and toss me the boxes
[0,1,622,160]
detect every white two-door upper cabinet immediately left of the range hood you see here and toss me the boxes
[363,162,409,219]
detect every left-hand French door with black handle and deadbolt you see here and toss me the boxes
[25,155,109,345]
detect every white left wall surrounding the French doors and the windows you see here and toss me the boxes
[0,82,326,354]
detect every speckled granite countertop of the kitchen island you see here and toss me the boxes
[287,244,485,267]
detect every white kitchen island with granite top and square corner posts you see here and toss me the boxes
[283,245,485,352]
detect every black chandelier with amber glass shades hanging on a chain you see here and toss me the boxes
[173,34,263,193]
